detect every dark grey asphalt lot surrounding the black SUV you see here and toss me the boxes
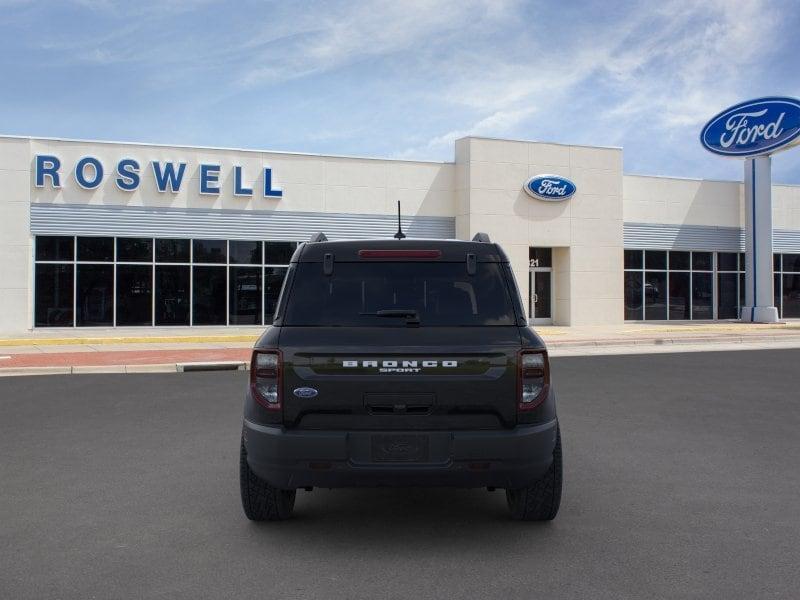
[0,350,800,600]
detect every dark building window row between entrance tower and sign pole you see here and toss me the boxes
[625,250,744,321]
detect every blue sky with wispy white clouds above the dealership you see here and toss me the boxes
[0,0,800,184]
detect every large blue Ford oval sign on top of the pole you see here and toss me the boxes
[700,97,800,157]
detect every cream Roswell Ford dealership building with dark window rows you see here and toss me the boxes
[0,137,800,336]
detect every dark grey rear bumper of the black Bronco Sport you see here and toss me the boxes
[243,419,558,489]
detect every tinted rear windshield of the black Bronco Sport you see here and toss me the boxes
[283,262,515,327]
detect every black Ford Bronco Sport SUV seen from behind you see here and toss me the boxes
[240,234,562,521]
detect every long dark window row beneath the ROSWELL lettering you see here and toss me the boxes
[34,236,297,327]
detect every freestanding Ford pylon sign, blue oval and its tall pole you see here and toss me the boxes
[700,97,800,323]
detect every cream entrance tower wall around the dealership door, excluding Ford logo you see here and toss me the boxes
[456,138,624,325]
